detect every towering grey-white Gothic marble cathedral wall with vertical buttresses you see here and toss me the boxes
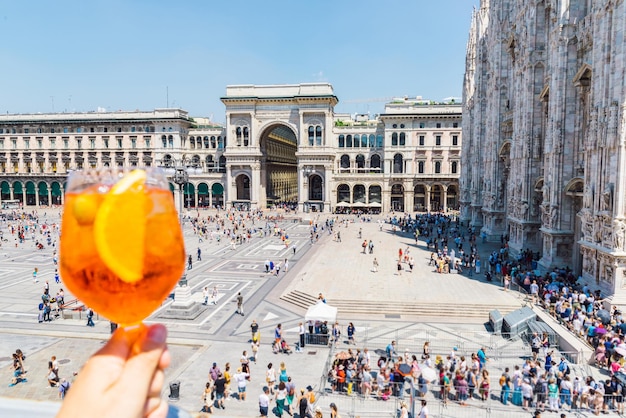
[460,0,626,305]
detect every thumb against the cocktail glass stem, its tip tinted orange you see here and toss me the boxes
[119,324,167,408]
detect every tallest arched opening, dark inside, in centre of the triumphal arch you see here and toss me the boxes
[259,124,298,206]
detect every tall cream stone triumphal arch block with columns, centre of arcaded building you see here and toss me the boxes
[221,83,337,212]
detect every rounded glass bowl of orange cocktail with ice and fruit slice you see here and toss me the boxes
[60,169,185,325]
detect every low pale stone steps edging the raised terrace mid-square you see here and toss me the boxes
[280,290,519,321]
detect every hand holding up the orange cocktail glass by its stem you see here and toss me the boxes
[57,324,171,418]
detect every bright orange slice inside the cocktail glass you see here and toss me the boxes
[93,170,148,283]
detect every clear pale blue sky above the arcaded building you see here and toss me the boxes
[0,0,480,122]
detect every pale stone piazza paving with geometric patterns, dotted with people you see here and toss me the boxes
[0,209,596,418]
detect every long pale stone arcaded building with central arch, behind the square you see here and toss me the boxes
[0,83,462,213]
